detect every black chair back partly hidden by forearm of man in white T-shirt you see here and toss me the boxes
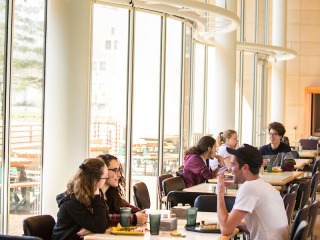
[194,194,236,212]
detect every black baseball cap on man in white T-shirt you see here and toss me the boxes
[227,143,263,168]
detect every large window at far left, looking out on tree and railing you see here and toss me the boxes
[0,0,45,234]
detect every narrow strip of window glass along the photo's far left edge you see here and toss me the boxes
[0,0,6,232]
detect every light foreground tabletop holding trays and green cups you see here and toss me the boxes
[84,209,239,240]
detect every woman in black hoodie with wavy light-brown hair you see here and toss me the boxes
[52,158,110,240]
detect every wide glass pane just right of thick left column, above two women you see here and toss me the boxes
[90,4,129,172]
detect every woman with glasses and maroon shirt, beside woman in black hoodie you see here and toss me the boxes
[98,154,148,226]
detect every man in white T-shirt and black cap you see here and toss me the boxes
[217,144,289,240]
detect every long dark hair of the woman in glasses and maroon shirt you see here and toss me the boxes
[98,154,126,214]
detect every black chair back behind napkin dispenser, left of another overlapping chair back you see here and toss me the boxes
[167,191,215,209]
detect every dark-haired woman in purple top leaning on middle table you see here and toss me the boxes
[181,136,223,187]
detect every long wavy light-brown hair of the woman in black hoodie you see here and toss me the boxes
[66,158,105,208]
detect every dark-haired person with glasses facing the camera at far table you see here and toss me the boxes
[259,122,296,171]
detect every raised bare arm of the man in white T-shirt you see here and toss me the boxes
[217,174,247,235]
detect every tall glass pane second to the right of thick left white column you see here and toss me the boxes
[131,12,161,208]
